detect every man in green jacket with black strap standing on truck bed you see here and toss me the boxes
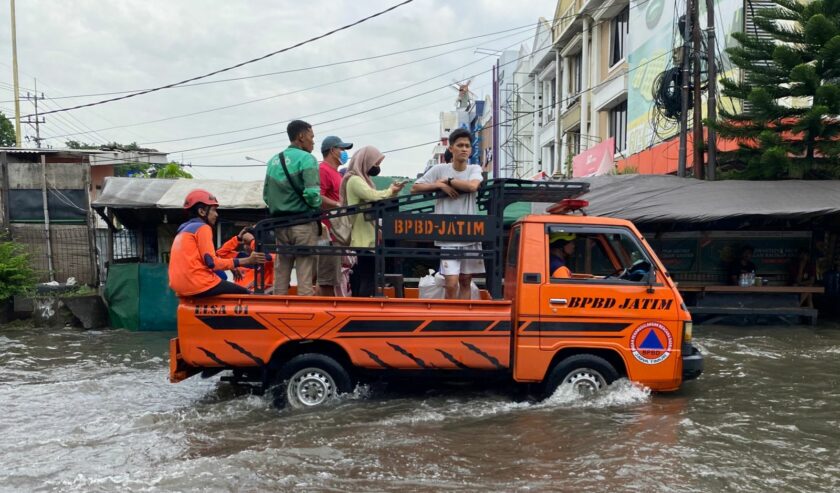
[263,120,321,296]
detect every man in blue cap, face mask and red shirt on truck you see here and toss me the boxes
[318,135,353,296]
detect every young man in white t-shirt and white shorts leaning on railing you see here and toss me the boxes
[411,128,484,300]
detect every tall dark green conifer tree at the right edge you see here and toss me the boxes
[707,0,840,180]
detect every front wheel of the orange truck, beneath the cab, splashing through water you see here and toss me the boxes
[543,354,618,399]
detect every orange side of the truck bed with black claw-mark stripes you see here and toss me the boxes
[170,295,511,381]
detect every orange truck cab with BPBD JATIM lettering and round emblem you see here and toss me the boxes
[505,208,702,391]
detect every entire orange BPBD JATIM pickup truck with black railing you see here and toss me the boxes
[170,179,703,408]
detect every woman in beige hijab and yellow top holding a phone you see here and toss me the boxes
[341,146,405,297]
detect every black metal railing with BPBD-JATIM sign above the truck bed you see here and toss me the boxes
[254,178,589,299]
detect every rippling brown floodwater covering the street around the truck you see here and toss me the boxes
[0,324,840,492]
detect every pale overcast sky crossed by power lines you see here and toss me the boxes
[0,0,556,180]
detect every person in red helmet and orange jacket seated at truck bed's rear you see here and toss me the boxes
[169,189,265,298]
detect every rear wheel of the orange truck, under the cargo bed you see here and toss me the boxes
[274,353,353,409]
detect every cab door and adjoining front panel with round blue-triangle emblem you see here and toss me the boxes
[540,225,682,388]
